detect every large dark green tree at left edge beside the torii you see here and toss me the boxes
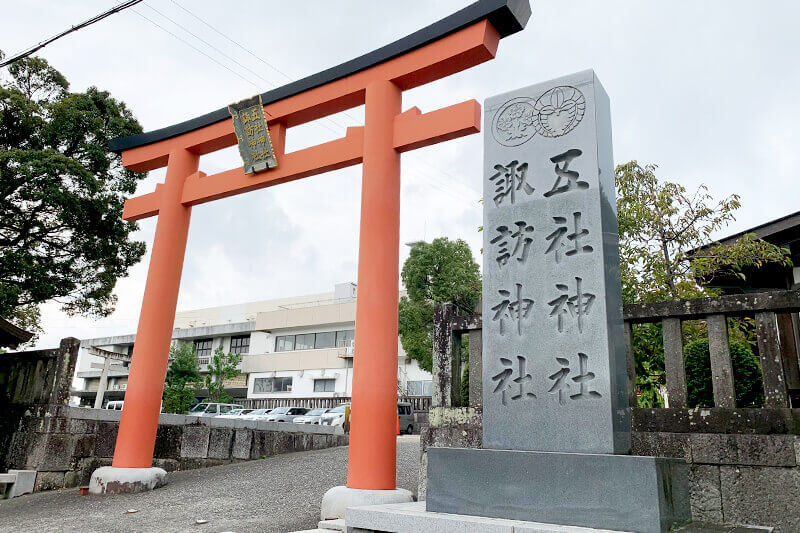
[0,57,145,331]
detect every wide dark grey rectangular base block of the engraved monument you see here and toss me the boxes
[426,448,691,533]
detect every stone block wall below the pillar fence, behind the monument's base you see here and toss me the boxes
[419,407,800,533]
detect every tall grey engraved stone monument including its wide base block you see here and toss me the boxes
[427,70,689,533]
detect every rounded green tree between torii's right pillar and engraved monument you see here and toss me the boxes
[398,237,481,372]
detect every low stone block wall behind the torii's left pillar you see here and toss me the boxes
[8,406,348,491]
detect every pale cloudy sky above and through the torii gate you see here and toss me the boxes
[0,0,800,346]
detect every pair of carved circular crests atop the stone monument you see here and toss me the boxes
[492,85,586,146]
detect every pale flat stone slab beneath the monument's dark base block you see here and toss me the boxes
[346,502,772,533]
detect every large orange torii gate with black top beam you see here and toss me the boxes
[93,0,530,492]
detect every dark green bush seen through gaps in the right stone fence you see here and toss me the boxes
[683,340,764,407]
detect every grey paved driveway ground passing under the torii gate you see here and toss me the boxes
[0,435,419,533]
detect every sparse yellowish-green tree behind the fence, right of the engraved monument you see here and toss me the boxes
[616,161,791,407]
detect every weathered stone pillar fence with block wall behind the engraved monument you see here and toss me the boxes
[428,290,800,532]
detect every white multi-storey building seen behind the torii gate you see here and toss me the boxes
[74,283,431,403]
